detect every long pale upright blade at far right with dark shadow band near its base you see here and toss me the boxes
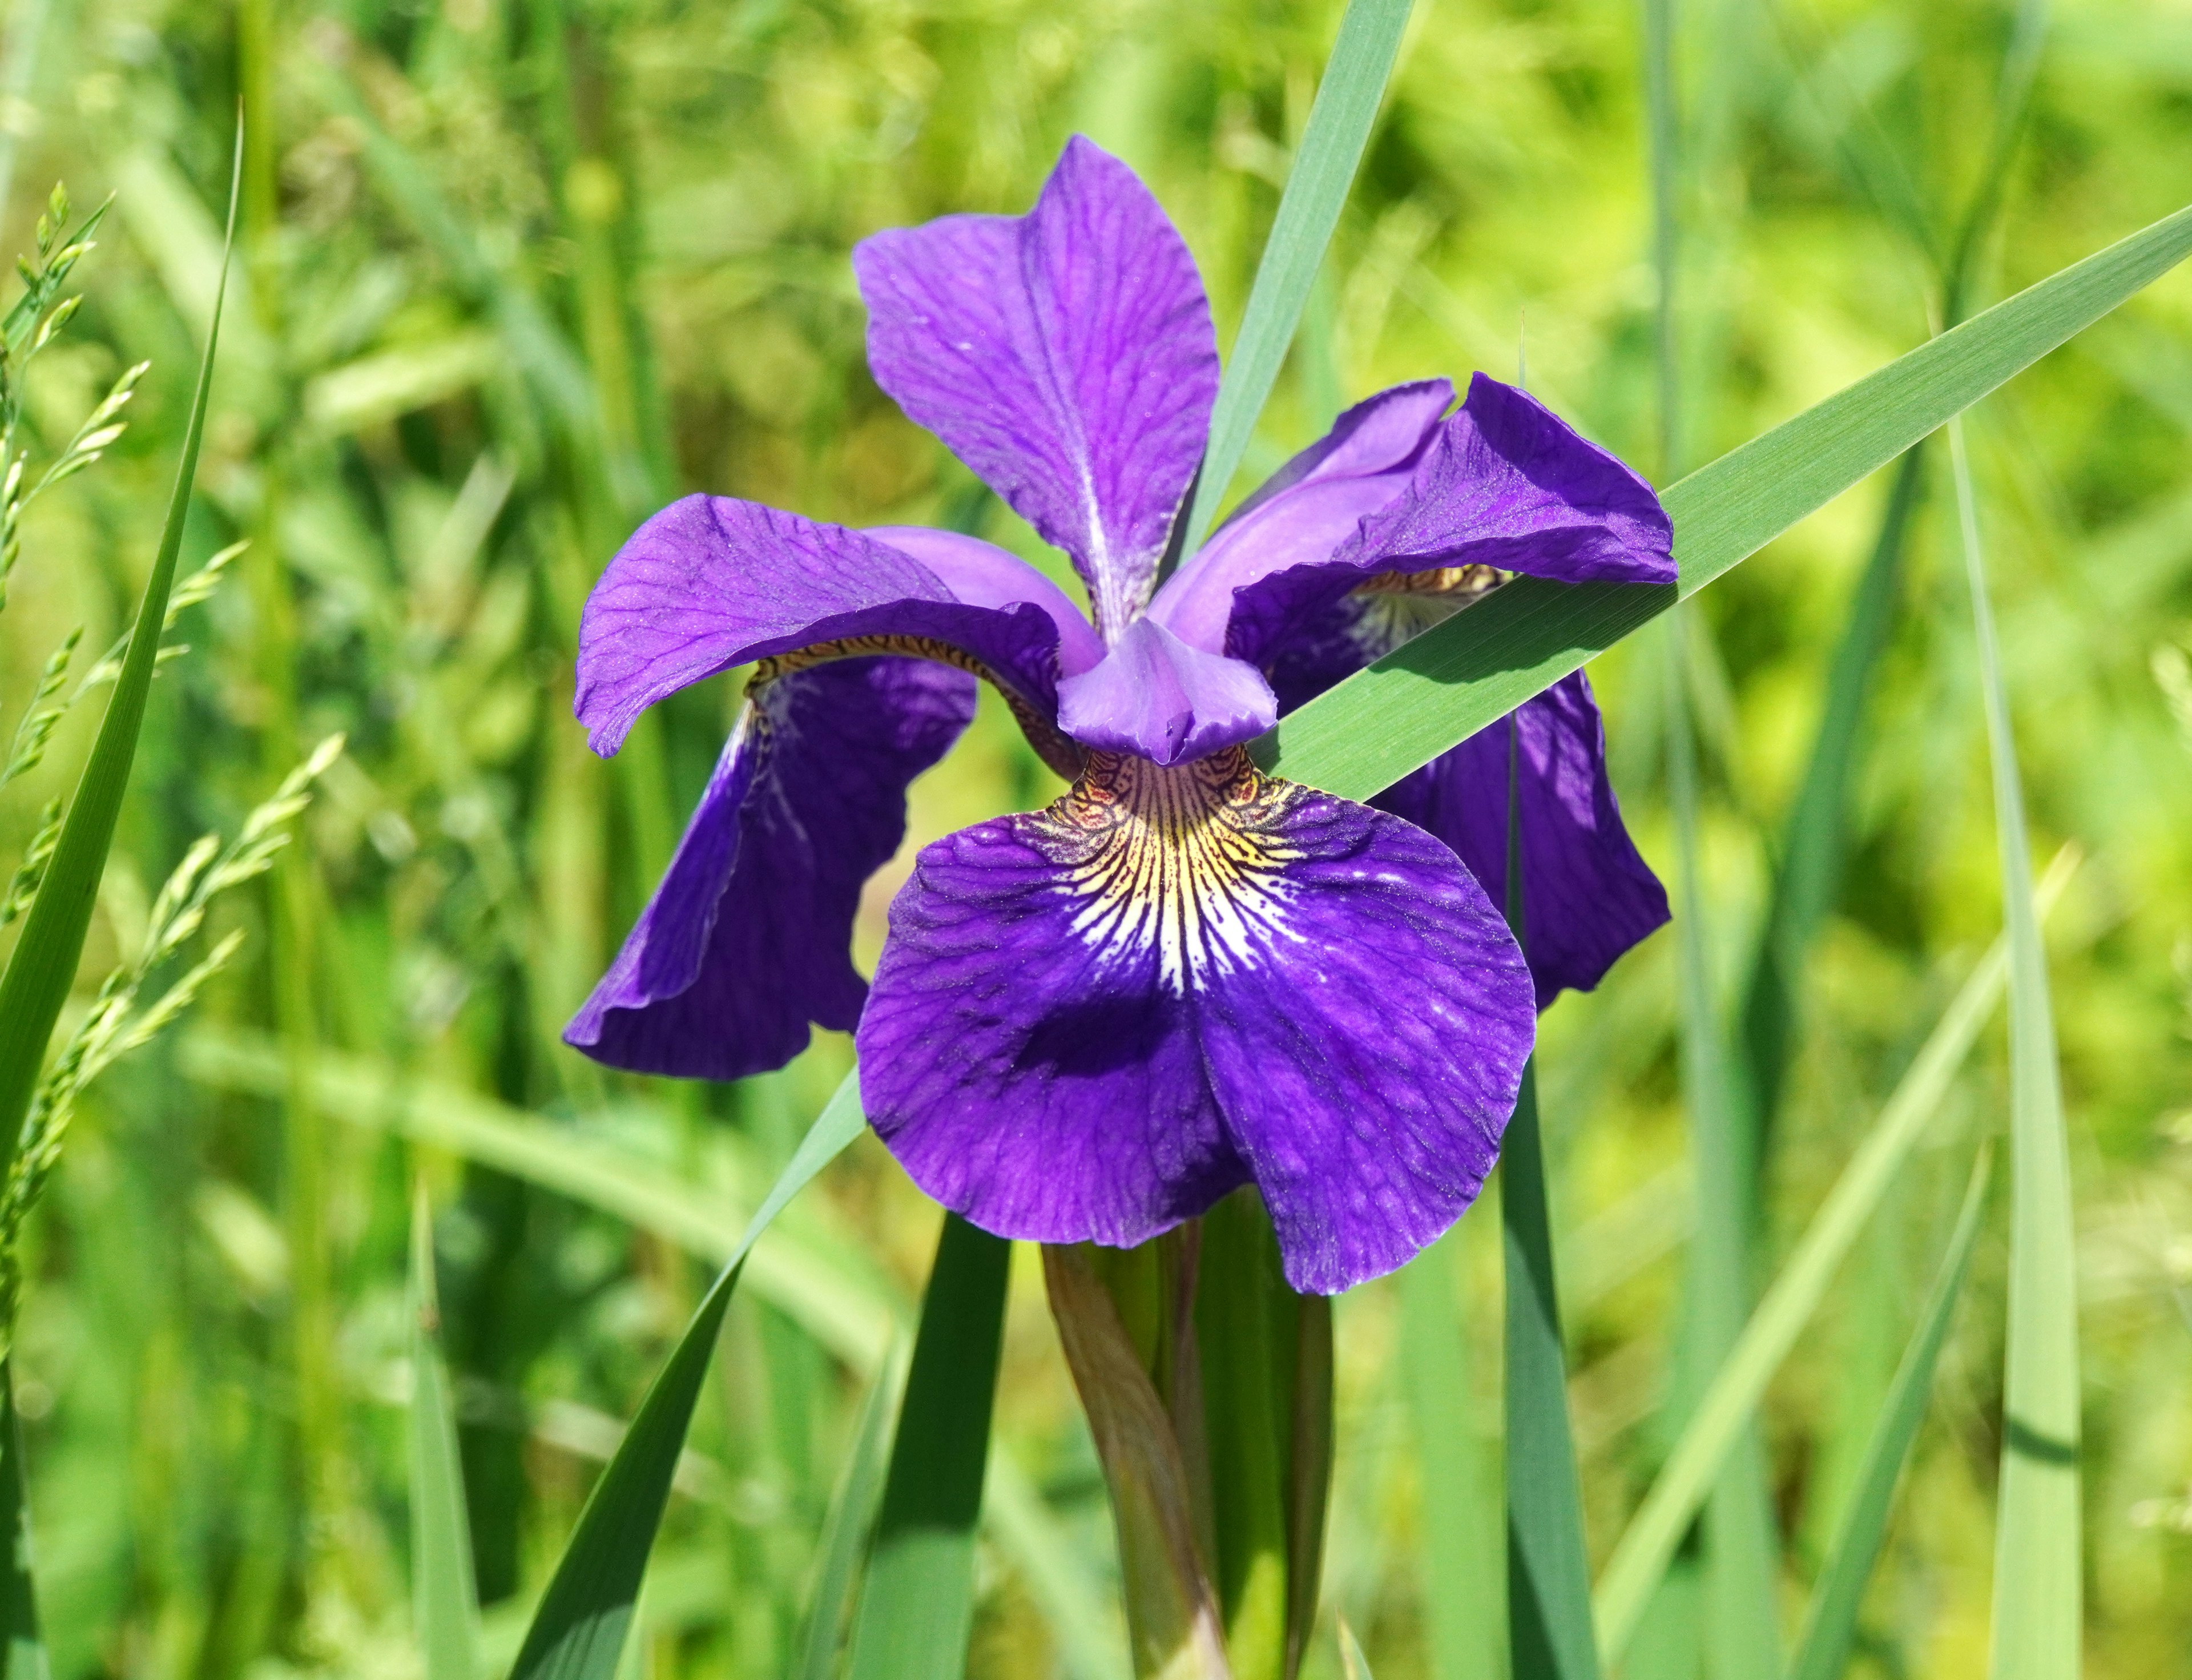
[1949,425,2082,1680]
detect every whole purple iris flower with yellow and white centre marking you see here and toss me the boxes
[566,138,1675,1292]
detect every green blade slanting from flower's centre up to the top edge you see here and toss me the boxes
[1182,0,1412,570]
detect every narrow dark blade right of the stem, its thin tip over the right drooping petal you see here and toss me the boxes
[1500,719,1598,1680]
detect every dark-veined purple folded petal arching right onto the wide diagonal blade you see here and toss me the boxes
[1226,373,1675,664]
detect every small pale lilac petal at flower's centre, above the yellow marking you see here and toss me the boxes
[1059,618,1278,763]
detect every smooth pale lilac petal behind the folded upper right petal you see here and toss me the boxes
[1149,380,1453,654]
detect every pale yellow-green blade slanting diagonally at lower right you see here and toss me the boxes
[1596,857,2072,1662]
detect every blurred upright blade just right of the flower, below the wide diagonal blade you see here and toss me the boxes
[1657,612,1780,1680]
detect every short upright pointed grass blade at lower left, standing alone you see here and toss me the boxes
[410,1185,480,1680]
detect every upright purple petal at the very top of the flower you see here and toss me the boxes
[853,136,1219,638]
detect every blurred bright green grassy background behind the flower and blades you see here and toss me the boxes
[0,0,2192,1680]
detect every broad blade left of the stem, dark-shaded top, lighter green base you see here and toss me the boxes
[851,1213,1013,1680]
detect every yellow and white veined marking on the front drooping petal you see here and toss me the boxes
[1024,748,1308,996]
